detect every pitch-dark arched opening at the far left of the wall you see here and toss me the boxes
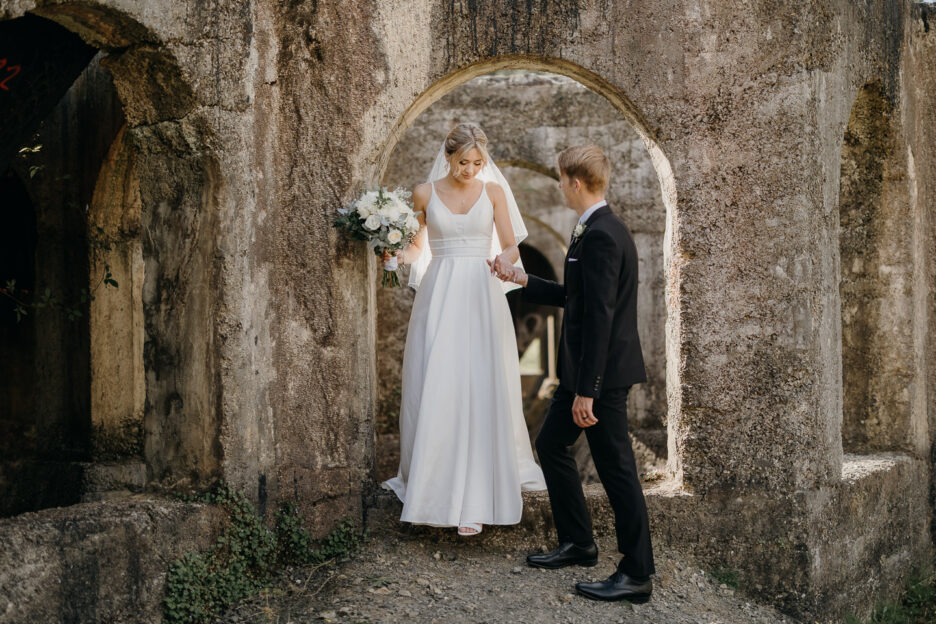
[0,15,107,515]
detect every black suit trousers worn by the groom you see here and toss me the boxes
[536,387,654,577]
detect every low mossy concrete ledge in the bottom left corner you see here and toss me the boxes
[0,500,226,624]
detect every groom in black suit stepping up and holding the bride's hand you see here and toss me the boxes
[491,145,654,603]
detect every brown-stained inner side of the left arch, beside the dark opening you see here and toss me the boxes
[1,3,220,502]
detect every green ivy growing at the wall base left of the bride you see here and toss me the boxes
[163,485,361,624]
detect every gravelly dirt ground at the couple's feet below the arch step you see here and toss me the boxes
[219,532,795,624]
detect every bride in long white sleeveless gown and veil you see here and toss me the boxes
[383,123,546,535]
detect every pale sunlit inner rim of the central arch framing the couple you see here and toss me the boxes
[368,57,681,477]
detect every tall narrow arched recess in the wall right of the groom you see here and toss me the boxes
[839,82,915,453]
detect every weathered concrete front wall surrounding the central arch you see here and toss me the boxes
[0,0,934,617]
